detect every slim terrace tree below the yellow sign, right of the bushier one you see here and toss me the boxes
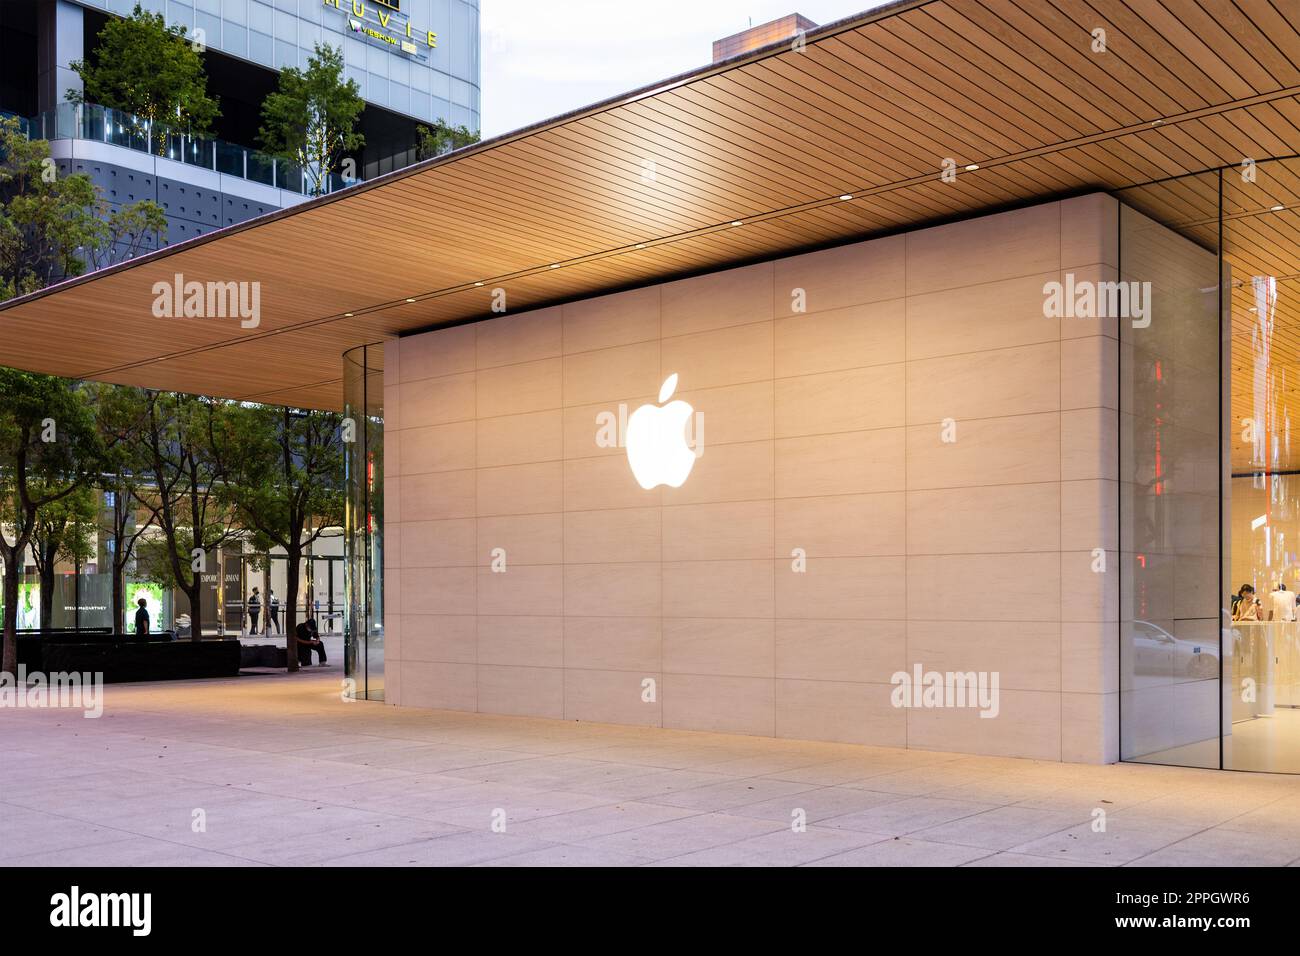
[259,43,365,195]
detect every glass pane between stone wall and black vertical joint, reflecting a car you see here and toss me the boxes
[1118,173,1222,767]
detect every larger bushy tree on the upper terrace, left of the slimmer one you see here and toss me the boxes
[68,4,221,145]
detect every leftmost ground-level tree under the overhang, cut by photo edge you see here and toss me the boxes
[0,368,103,674]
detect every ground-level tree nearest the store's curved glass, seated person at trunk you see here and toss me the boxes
[228,405,345,671]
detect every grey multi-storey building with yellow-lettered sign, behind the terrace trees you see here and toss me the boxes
[0,0,480,252]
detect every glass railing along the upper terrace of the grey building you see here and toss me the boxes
[20,103,359,195]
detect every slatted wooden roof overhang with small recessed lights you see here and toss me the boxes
[0,0,1300,408]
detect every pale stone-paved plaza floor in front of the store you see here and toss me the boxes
[0,659,1300,866]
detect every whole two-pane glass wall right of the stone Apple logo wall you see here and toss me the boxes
[1119,159,1300,773]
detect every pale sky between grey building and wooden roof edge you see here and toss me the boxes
[480,0,880,139]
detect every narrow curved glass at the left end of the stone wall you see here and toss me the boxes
[340,345,384,700]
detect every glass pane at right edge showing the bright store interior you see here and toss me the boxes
[1223,160,1300,773]
